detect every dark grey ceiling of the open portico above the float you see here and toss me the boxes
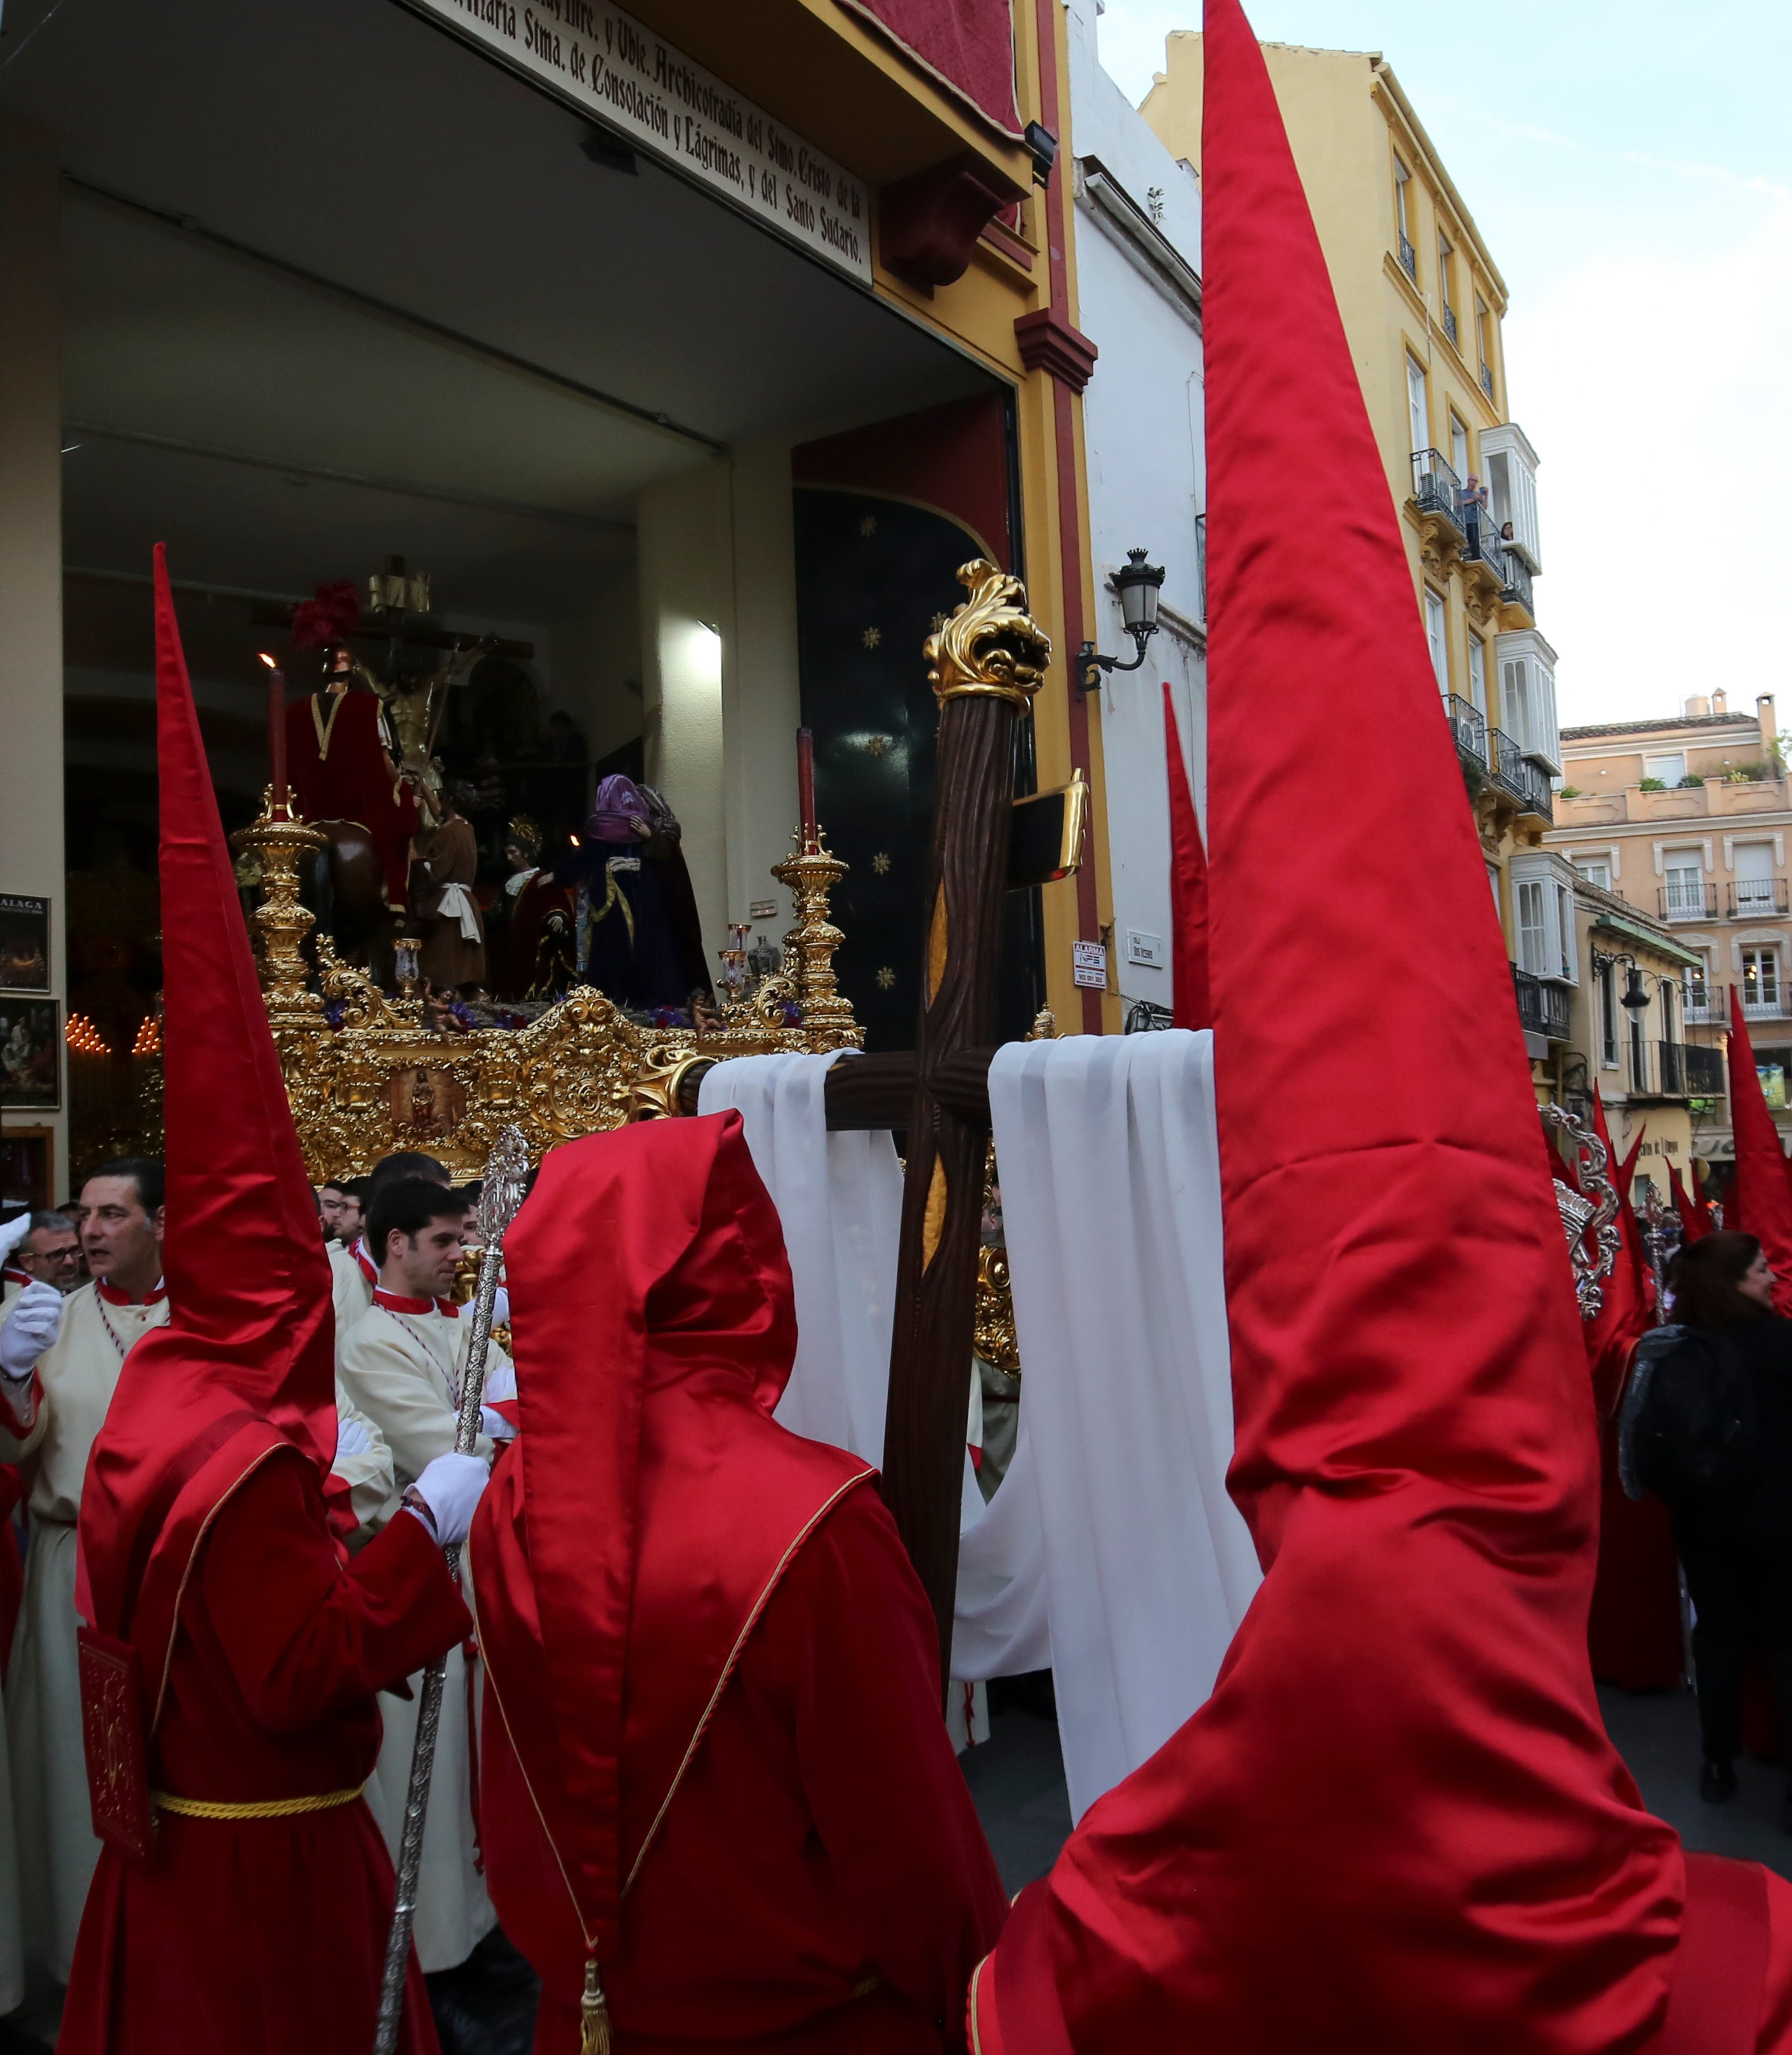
[0,0,986,621]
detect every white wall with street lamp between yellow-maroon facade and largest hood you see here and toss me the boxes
[1067,0,1206,1023]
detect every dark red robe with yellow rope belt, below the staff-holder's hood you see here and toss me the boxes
[58,1459,471,2055]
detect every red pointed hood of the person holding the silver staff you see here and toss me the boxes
[80,545,337,1673]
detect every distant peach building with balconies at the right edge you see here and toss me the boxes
[1548,692,1792,1161]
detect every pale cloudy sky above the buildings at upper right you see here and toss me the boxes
[1102,0,1792,729]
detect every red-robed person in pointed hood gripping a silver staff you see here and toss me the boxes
[60,549,468,2055]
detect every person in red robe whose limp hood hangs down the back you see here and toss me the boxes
[468,1114,1007,2055]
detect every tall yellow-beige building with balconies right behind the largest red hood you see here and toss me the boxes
[1140,33,1574,1089]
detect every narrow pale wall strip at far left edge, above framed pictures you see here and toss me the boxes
[0,119,70,1204]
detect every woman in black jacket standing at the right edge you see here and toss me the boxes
[1626,1233,1792,1831]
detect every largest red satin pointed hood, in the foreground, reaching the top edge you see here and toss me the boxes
[978,0,1683,2055]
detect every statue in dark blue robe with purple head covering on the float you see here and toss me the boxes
[571,775,713,1011]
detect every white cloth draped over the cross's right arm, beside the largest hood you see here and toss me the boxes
[951,1029,1260,1816]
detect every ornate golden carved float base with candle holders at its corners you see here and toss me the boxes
[230,787,865,1182]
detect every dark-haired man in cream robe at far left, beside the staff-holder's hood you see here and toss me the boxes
[0,1157,169,1983]
